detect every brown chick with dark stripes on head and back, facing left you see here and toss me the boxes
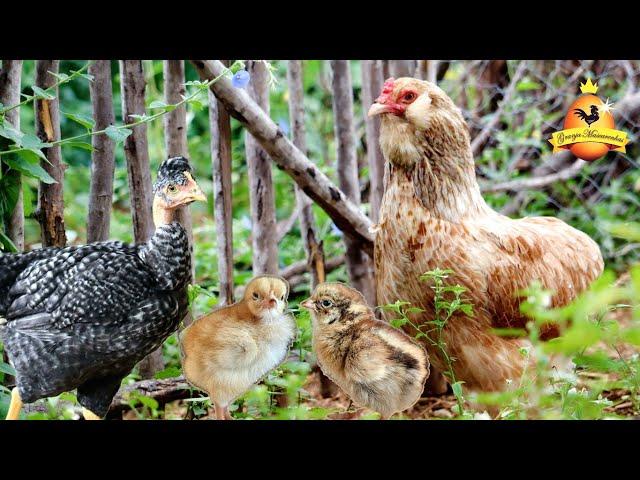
[300,283,429,419]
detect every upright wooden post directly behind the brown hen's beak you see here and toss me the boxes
[361,60,384,223]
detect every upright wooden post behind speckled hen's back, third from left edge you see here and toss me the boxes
[87,60,115,243]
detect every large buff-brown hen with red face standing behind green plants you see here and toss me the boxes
[369,78,603,390]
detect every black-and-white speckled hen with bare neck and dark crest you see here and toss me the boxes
[0,157,206,419]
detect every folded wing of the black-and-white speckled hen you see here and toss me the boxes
[2,242,178,370]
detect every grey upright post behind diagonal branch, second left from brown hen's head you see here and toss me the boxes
[331,60,376,306]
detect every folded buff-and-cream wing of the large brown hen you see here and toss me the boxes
[485,217,604,334]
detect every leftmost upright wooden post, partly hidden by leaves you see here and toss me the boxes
[0,60,24,252]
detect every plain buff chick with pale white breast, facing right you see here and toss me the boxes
[180,275,296,420]
